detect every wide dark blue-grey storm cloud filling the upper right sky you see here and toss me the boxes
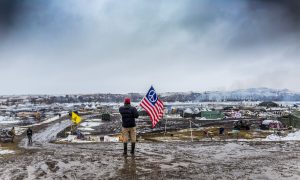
[179,0,300,48]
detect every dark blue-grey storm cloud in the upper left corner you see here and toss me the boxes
[0,0,76,40]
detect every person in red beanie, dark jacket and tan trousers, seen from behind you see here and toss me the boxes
[119,98,139,155]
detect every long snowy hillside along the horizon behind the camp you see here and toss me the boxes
[0,88,300,102]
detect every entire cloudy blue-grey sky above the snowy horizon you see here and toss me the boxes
[0,0,300,94]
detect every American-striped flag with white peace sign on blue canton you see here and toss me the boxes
[140,86,164,127]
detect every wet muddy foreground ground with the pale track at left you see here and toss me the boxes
[0,115,300,180]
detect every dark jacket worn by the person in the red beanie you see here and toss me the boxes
[119,104,139,128]
